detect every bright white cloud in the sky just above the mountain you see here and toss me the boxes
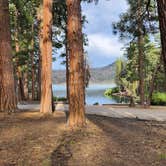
[87,33,123,58]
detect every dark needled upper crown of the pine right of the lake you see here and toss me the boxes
[113,0,158,41]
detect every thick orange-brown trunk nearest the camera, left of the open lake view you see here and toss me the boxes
[66,0,85,127]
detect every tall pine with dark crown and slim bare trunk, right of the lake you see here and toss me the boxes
[113,0,158,105]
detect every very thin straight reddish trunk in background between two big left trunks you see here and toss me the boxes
[31,24,35,100]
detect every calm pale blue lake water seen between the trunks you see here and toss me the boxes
[53,84,127,105]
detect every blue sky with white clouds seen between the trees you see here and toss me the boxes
[53,0,127,69]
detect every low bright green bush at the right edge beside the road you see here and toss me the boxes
[151,92,166,105]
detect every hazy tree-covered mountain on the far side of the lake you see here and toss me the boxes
[53,63,116,84]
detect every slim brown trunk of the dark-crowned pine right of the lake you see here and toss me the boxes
[138,0,145,105]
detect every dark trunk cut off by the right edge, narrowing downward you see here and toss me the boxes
[157,0,166,75]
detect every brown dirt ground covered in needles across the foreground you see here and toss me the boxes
[0,112,166,166]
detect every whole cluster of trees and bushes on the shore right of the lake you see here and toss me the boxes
[105,0,166,106]
